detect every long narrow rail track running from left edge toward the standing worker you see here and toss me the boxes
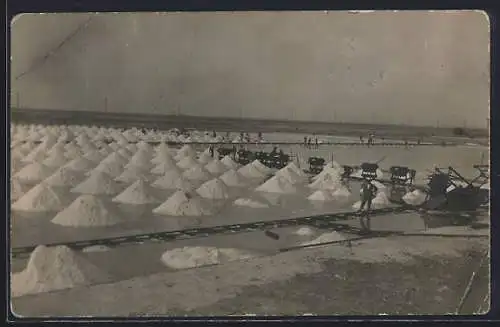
[11,207,414,259]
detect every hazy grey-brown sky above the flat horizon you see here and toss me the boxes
[11,11,490,128]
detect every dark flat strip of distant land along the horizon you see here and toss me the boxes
[10,108,489,145]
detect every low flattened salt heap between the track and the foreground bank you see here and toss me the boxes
[161,246,256,269]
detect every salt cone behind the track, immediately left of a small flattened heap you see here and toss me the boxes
[153,191,212,216]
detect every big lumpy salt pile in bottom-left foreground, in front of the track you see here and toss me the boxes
[11,245,112,297]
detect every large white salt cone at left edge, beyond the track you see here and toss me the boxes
[12,182,67,212]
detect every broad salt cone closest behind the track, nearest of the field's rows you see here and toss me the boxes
[52,194,123,227]
